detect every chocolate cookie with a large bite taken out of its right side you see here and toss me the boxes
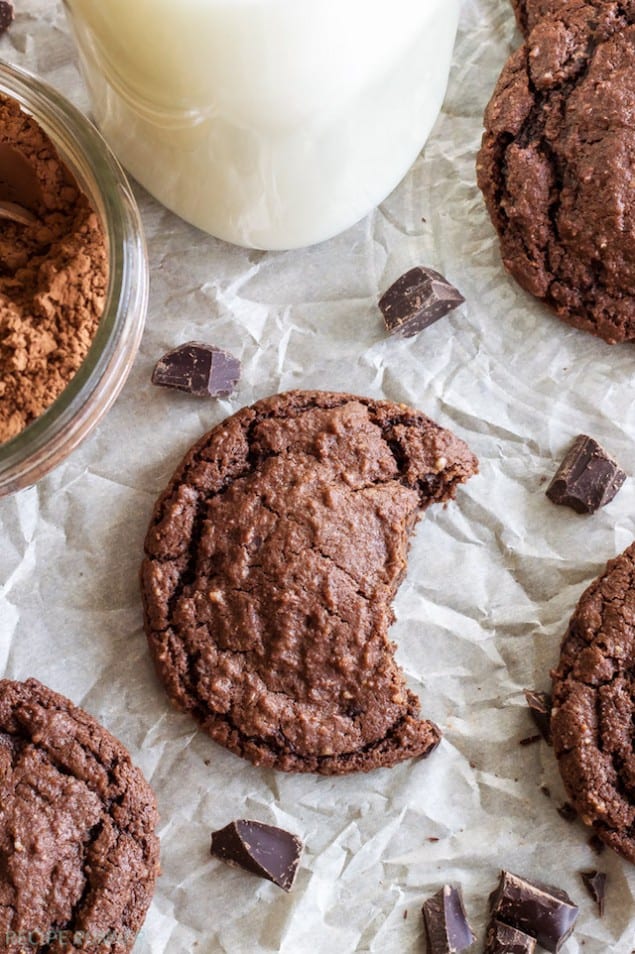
[142,391,477,774]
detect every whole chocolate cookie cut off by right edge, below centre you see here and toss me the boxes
[551,544,635,862]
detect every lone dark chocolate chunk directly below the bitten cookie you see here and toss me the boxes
[211,818,302,891]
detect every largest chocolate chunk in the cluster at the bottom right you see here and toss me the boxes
[491,871,578,952]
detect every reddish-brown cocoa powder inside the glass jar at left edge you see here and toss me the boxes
[0,95,108,443]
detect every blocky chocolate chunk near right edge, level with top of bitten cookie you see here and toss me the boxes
[546,434,626,513]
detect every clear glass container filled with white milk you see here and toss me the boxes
[65,0,459,249]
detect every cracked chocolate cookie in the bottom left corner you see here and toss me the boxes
[0,679,159,954]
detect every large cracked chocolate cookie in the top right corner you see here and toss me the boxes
[477,0,635,343]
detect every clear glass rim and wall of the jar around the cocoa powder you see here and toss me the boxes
[0,63,148,496]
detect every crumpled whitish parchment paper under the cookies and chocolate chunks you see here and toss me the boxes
[0,0,635,954]
